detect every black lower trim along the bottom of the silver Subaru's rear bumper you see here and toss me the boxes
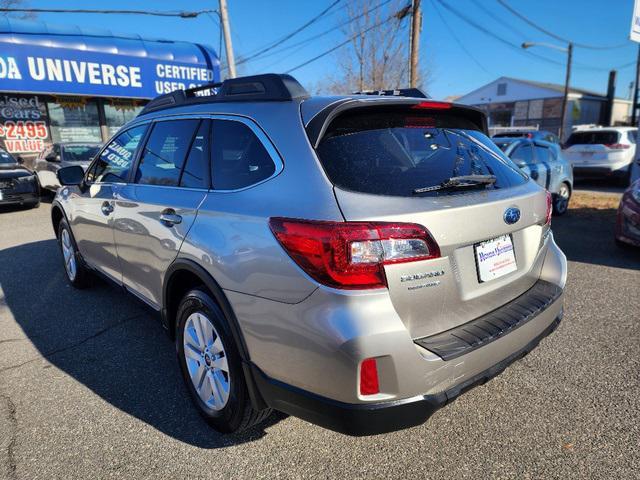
[251,314,562,436]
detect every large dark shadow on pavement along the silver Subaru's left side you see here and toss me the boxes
[0,240,285,448]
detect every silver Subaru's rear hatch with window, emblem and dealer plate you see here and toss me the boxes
[316,102,548,338]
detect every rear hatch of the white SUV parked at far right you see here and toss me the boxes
[563,130,631,166]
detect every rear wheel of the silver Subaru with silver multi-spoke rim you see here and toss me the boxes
[176,289,271,433]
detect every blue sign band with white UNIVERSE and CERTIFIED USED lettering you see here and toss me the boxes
[0,42,220,99]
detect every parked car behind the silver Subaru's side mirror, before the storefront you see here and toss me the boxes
[34,142,101,192]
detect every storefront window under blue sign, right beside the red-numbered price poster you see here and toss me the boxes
[47,97,102,142]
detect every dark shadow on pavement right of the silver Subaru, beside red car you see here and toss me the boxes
[551,208,640,270]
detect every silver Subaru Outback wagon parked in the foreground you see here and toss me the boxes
[51,74,567,435]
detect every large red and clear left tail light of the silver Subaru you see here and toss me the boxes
[269,218,440,289]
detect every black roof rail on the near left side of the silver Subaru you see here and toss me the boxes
[140,73,309,115]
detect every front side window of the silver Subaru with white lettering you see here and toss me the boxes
[87,125,147,183]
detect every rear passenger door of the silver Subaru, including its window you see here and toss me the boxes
[114,118,210,307]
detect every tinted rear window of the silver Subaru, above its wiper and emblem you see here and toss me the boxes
[317,111,526,196]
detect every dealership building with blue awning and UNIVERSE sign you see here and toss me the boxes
[0,17,220,160]
